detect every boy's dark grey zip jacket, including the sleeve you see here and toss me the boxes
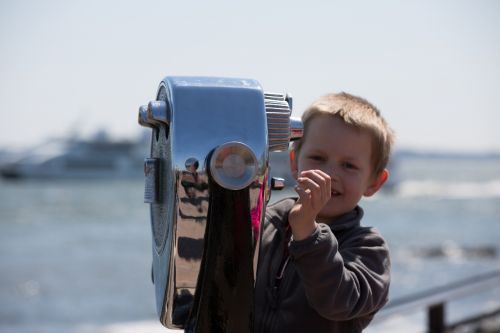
[255,198,390,333]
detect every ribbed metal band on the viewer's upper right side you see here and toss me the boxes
[264,93,292,151]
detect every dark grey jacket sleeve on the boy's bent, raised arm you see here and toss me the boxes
[289,223,390,321]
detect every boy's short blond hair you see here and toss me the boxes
[294,92,394,176]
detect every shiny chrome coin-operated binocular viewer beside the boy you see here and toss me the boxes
[139,77,302,332]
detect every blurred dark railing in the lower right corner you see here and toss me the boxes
[373,270,500,333]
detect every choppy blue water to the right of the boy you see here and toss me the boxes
[362,159,500,332]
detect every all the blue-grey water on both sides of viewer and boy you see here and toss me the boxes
[0,159,500,333]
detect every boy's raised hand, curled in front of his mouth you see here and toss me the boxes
[288,170,332,240]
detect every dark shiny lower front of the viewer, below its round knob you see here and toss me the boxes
[185,180,263,333]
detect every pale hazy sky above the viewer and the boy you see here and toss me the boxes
[0,0,500,152]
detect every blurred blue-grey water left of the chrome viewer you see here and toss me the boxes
[0,180,156,332]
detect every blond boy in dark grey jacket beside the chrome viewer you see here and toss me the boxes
[255,93,393,333]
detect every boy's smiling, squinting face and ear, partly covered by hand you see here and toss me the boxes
[291,115,388,218]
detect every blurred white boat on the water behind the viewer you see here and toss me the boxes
[0,132,149,179]
